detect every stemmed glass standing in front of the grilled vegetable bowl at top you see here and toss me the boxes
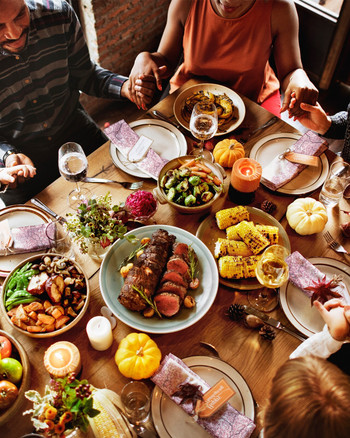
[190,101,218,161]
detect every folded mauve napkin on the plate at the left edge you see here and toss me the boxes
[0,219,51,255]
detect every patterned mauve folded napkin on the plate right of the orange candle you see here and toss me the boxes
[261,131,328,190]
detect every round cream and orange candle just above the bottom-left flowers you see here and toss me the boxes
[44,341,81,377]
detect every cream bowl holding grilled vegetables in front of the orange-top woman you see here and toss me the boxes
[173,83,245,136]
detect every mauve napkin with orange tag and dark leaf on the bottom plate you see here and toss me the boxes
[151,353,255,438]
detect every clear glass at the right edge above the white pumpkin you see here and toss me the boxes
[319,161,350,207]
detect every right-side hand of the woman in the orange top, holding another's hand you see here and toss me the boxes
[281,69,318,118]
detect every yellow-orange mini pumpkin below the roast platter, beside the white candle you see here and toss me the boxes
[115,333,162,380]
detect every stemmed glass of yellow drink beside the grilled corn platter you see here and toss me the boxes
[248,245,290,312]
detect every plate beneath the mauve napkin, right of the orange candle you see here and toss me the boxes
[249,132,329,195]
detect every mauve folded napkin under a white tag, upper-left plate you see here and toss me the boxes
[105,120,168,179]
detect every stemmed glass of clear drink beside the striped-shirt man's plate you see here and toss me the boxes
[58,142,91,209]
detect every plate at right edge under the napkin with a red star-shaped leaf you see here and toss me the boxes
[280,257,350,337]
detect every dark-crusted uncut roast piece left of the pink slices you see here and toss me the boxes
[118,229,175,311]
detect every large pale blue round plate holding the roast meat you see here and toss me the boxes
[100,225,219,334]
